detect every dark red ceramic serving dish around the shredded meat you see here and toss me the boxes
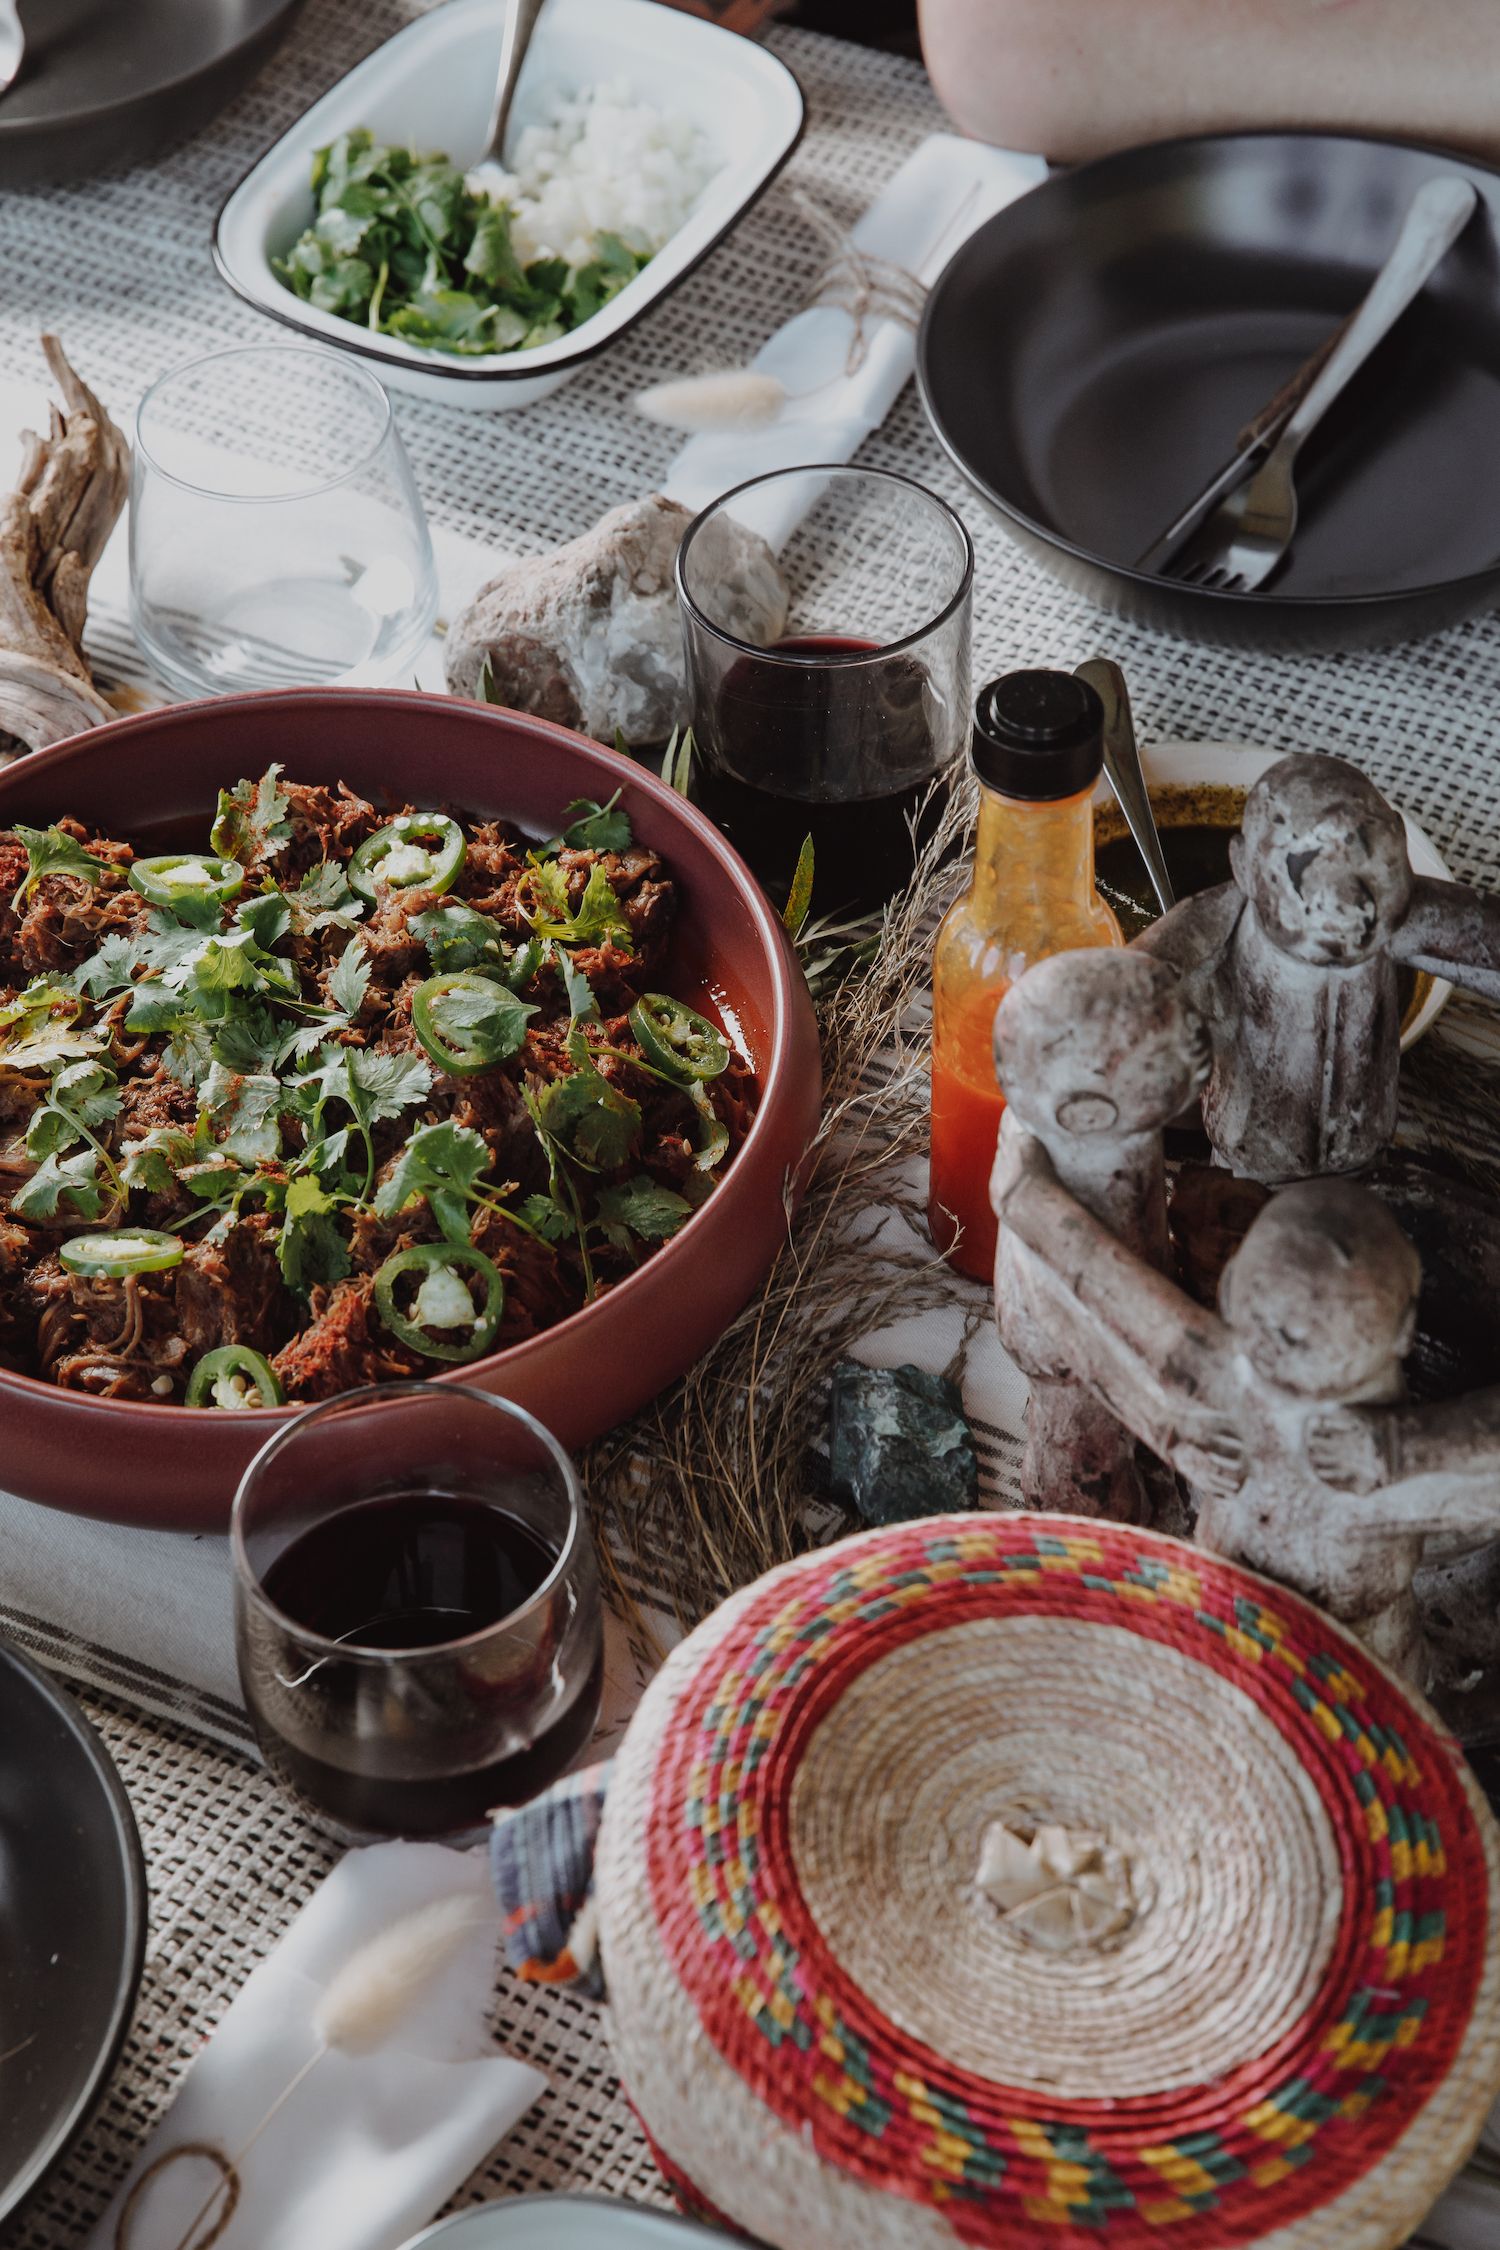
[0,689,821,1530]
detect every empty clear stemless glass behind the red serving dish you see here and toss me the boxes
[130,344,439,695]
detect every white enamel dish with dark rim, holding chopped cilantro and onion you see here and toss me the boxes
[214,0,803,407]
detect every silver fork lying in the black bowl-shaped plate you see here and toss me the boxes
[1167,173,1480,594]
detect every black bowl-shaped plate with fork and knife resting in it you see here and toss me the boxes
[918,133,1500,648]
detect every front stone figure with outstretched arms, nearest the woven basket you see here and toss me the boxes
[994,1107,1500,1685]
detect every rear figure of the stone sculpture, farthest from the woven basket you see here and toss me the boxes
[1136,756,1500,1186]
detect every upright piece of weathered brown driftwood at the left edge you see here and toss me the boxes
[0,335,130,761]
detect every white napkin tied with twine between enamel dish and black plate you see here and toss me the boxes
[661,133,1048,547]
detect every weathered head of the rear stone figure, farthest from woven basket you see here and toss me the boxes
[1230,756,1412,968]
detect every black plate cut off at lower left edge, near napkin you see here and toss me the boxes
[0,1640,146,2225]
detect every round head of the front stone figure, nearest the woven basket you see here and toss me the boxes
[1219,1179,1421,1400]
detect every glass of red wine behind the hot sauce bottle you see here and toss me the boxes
[677,466,974,916]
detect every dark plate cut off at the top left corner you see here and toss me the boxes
[0,0,304,187]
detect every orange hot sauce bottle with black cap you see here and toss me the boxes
[927,671,1124,1280]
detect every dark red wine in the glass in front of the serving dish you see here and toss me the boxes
[247,1492,603,1836]
